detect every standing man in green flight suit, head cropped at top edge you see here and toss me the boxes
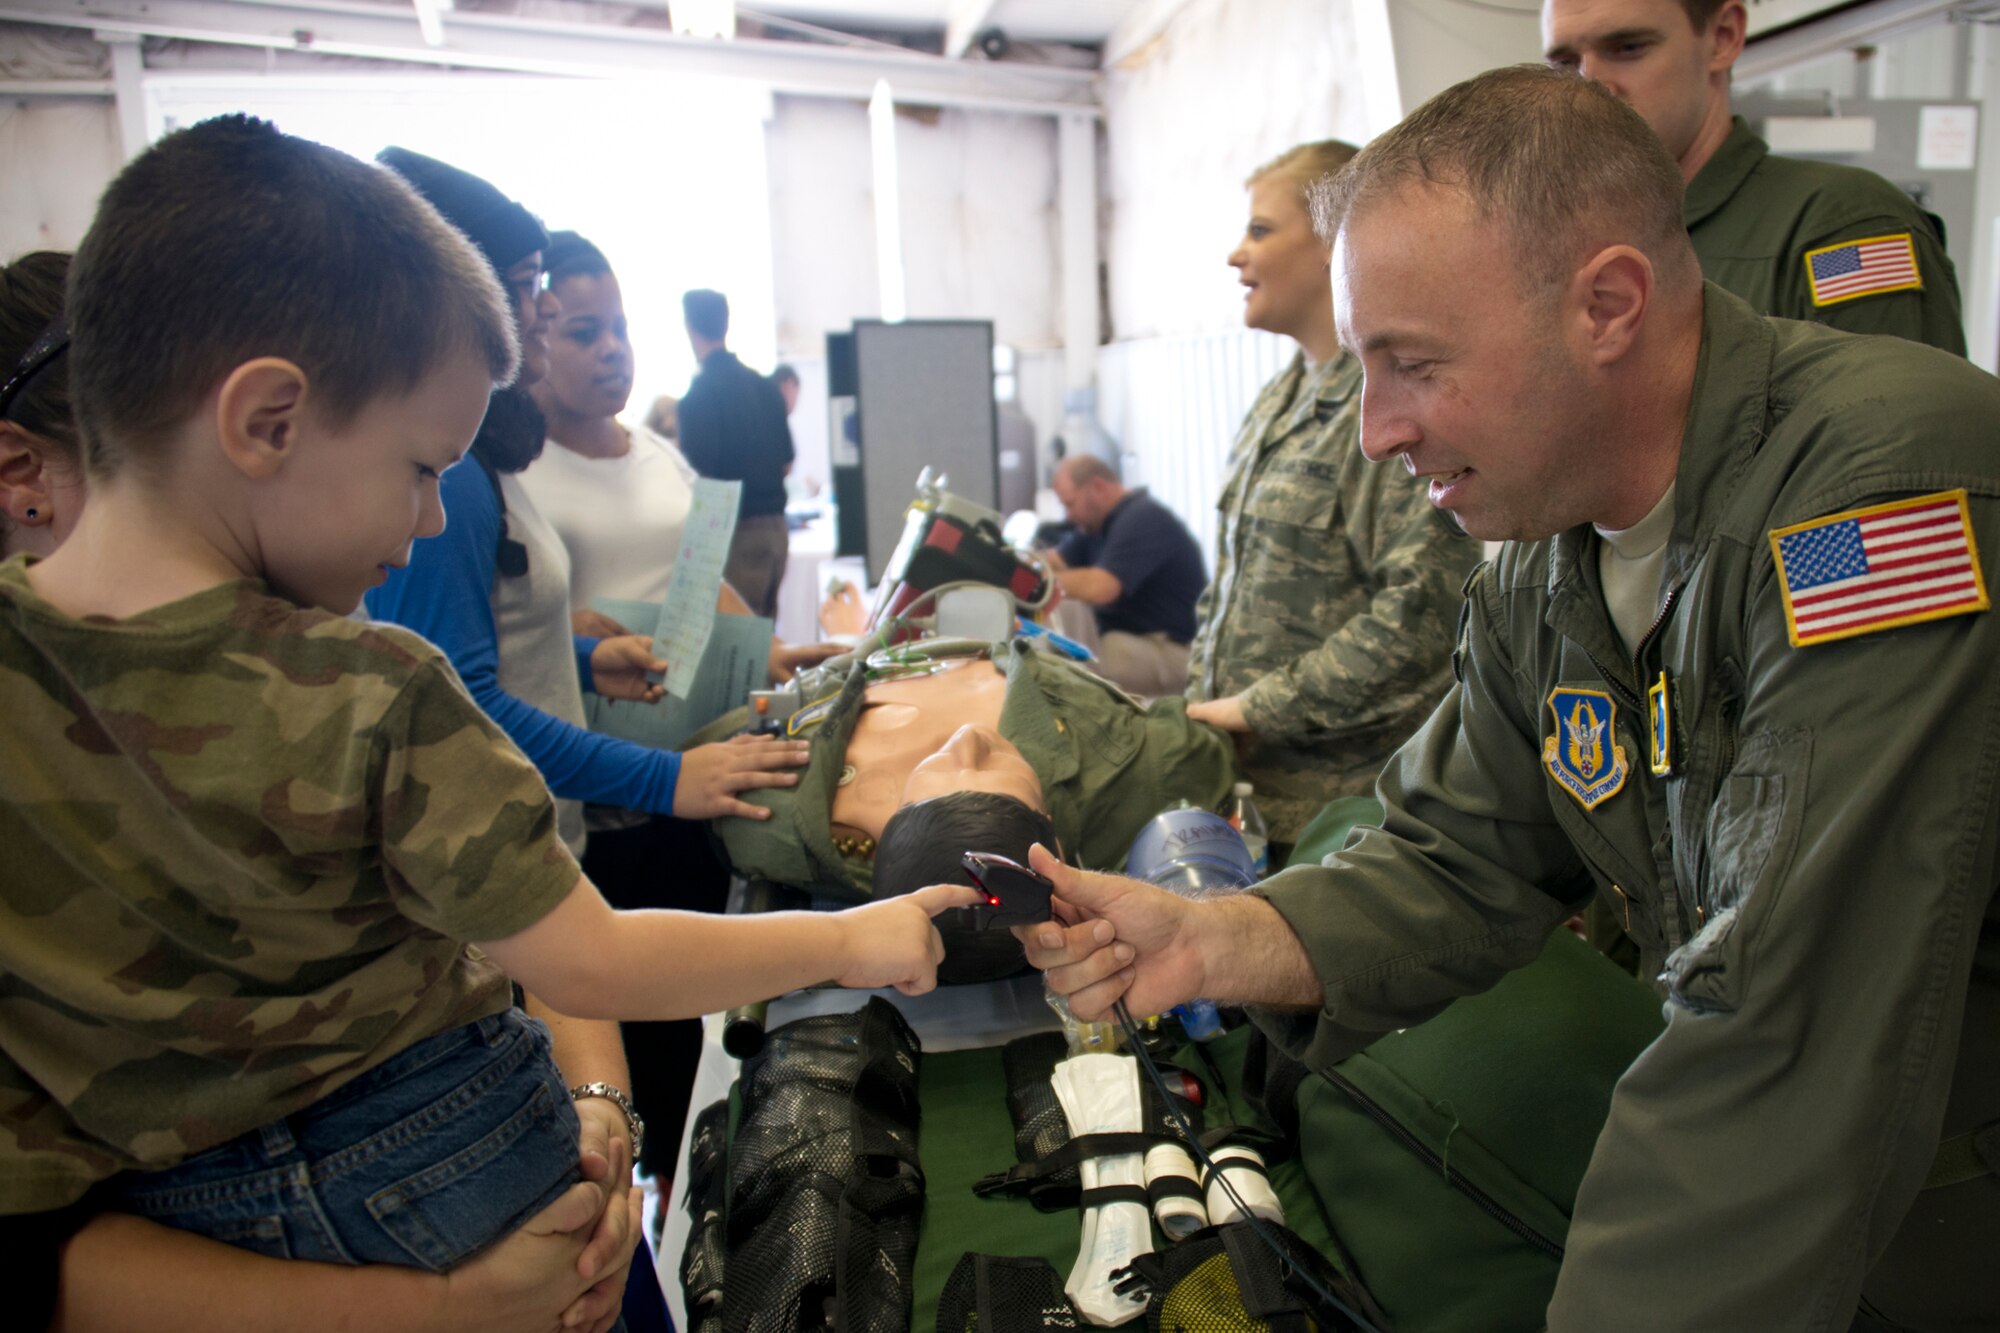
[1542,0,1966,356]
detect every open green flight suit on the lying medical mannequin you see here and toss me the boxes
[694,642,1236,899]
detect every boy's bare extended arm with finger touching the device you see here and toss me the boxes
[482,879,978,1019]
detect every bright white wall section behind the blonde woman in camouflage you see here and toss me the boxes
[1098,0,1368,554]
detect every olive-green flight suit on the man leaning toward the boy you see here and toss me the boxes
[1258,284,2000,1333]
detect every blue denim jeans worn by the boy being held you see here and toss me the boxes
[114,1009,582,1273]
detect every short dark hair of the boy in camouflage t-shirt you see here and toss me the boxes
[68,116,520,476]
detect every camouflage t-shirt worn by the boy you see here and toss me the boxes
[0,558,578,1213]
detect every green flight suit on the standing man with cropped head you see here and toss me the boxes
[1682,116,1966,356]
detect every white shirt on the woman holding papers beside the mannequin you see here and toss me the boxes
[520,426,694,608]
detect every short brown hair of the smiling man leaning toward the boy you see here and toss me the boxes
[1312,64,1700,292]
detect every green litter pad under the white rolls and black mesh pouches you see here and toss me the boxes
[910,1027,1332,1333]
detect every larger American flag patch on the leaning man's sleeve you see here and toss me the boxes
[1770,490,1990,648]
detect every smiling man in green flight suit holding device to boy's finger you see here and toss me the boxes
[1020,66,2000,1333]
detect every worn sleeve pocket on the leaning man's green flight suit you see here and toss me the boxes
[1660,733,1810,1013]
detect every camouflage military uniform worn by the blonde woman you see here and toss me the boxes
[1188,354,1480,843]
